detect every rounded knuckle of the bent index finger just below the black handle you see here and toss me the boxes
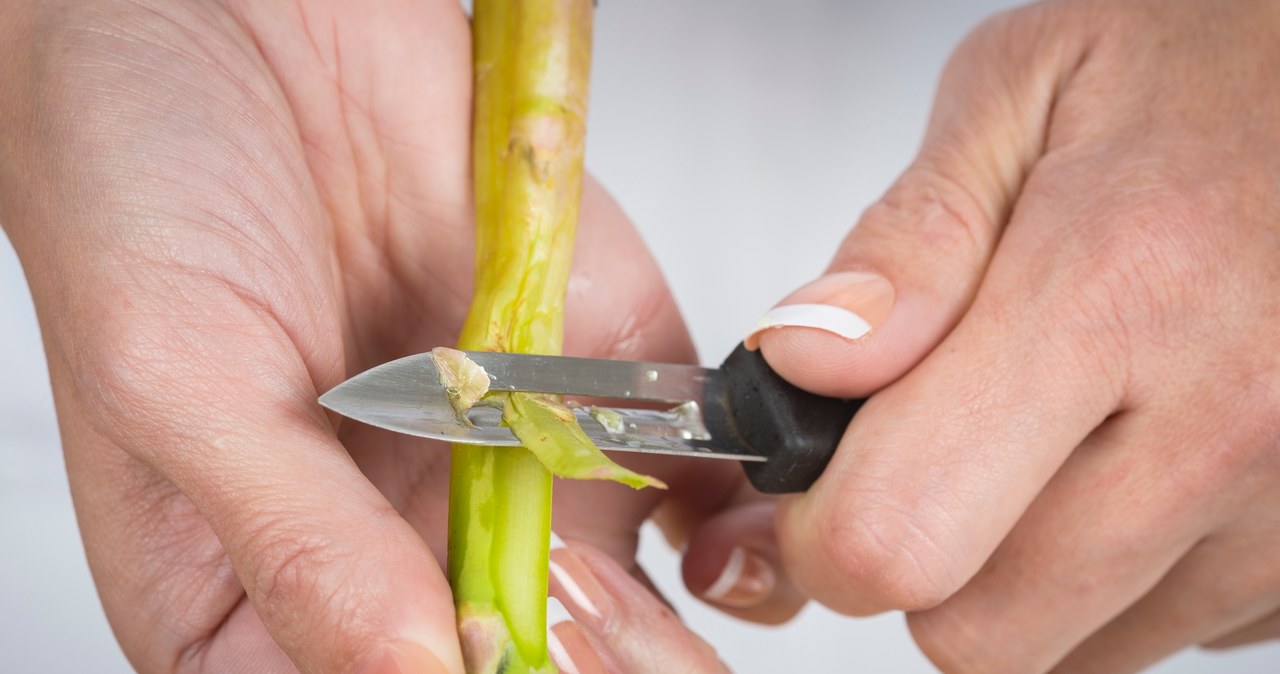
[819,491,960,613]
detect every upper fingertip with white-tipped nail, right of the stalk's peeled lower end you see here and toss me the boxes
[550,537,727,674]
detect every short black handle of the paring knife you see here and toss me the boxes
[703,344,865,494]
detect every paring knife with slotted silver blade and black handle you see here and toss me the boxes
[320,345,863,494]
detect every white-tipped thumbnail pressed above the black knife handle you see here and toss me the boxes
[742,271,893,349]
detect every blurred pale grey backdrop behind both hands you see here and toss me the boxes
[0,0,1280,674]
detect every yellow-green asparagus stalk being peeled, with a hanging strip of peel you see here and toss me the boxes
[450,0,660,674]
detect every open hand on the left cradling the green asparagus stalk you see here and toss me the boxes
[0,0,732,673]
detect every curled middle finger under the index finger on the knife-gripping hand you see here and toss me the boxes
[908,412,1222,674]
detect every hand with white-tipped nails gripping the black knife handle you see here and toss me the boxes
[686,0,1280,674]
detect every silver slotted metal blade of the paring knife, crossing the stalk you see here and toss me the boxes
[320,353,764,460]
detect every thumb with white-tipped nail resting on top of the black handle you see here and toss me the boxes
[748,9,1076,396]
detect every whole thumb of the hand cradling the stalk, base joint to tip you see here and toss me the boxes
[81,294,462,673]
